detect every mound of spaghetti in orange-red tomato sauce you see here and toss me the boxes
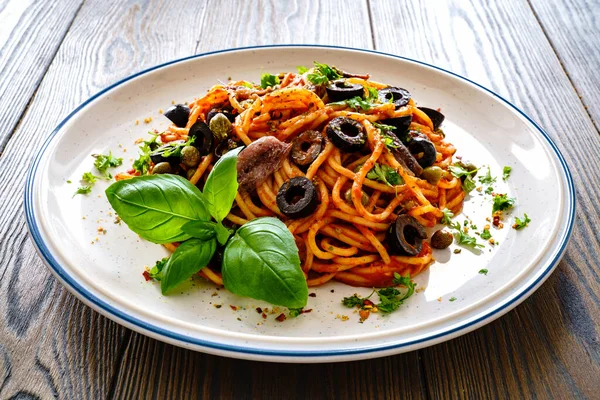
[135,66,465,287]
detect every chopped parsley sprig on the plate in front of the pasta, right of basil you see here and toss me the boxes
[342,272,416,314]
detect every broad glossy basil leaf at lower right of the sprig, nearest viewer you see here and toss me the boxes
[222,217,308,308]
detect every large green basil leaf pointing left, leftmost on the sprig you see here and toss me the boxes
[106,174,210,243]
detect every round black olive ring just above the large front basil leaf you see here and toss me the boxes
[277,176,319,219]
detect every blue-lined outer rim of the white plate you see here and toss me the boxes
[24,44,576,359]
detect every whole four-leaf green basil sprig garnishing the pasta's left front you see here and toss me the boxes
[106,149,308,308]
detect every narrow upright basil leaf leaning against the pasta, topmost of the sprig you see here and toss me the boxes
[203,147,243,222]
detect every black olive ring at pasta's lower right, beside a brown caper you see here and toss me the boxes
[386,214,427,256]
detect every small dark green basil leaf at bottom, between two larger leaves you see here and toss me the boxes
[160,239,217,294]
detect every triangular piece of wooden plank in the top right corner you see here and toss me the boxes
[528,0,600,131]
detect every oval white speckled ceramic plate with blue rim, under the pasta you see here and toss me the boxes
[25,46,575,362]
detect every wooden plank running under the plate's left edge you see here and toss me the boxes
[0,0,205,399]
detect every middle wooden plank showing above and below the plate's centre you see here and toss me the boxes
[109,1,425,399]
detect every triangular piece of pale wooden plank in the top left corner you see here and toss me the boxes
[0,0,83,154]
